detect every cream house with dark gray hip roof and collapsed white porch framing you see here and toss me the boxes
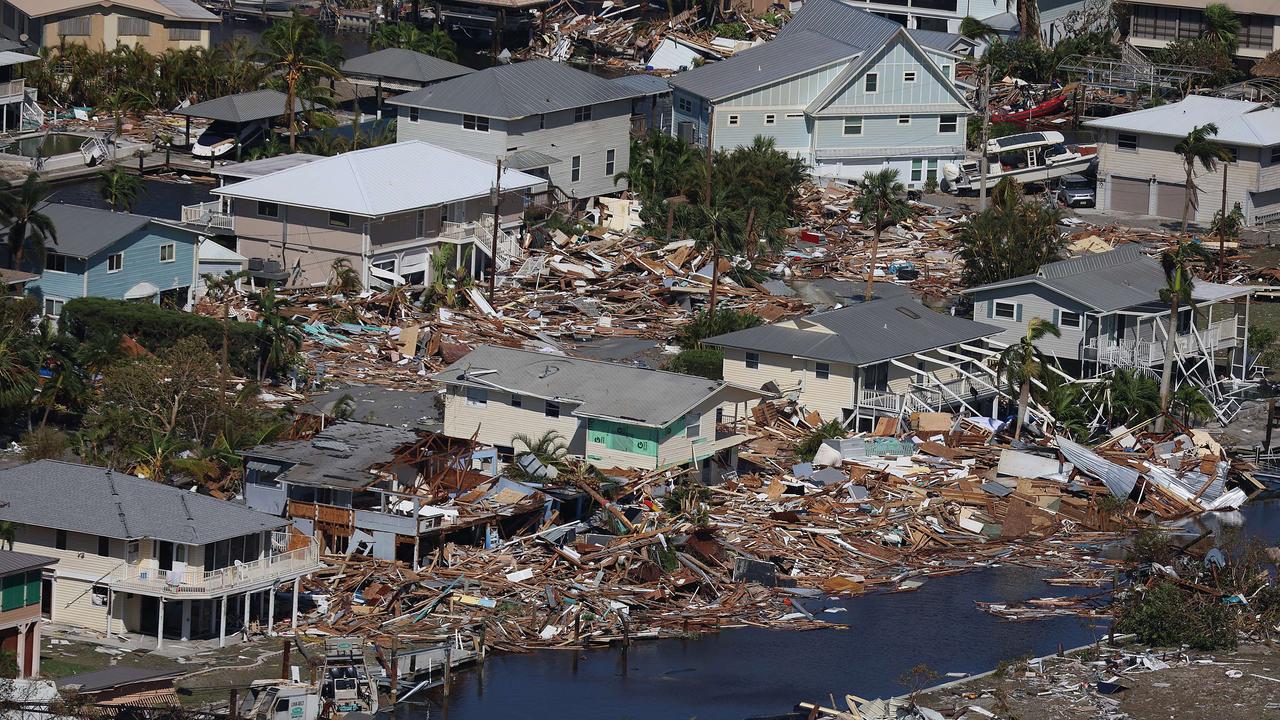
[703,286,1000,429]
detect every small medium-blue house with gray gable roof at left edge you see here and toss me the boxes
[6,204,200,316]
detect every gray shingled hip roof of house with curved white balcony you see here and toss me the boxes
[0,460,287,544]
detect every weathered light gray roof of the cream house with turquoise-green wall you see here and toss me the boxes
[435,345,726,429]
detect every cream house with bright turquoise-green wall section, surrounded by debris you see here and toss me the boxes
[435,345,764,482]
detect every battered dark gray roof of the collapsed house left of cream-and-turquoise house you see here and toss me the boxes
[242,420,417,489]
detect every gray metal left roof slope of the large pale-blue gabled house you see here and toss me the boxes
[671,29,861,100]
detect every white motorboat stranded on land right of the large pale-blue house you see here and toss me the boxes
[942,131,1097,193]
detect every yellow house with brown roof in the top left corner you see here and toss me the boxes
[0,0,221,53]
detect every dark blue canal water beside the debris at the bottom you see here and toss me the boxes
[386,500,1280,720]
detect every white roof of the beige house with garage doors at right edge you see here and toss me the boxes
[1084,95,1280,147]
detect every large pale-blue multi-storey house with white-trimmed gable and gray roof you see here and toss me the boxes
[671,0,973,187]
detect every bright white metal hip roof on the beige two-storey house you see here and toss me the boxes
[214,140,547,218]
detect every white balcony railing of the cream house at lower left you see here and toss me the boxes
[110,541,320,594]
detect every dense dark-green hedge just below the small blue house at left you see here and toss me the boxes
[59,297,265,375]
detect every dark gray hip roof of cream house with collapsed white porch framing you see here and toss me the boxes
[703,297,1001,365]
